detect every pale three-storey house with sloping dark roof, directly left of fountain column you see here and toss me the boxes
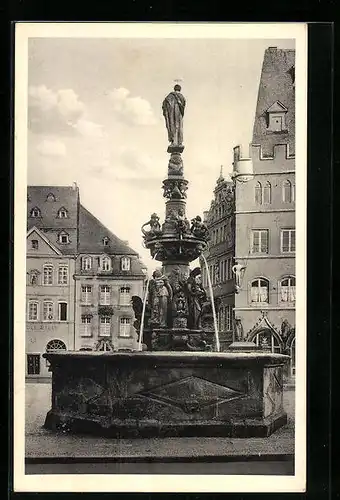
[74,206,145,350]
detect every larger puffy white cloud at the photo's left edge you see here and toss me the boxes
[28,85,103,137]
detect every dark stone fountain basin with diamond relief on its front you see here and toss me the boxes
[44,351,289,437]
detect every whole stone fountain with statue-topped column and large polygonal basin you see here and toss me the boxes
[44,85,288,437]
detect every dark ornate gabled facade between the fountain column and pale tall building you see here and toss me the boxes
[200,167,235,349]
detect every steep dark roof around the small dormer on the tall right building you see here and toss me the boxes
[252,47,295,154]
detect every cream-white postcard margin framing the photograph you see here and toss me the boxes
[13,22,307,493]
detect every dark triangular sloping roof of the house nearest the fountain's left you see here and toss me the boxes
[78,205,138,256]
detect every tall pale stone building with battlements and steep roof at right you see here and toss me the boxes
[233,47,295,375]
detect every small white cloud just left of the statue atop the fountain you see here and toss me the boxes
[109,87,156,126]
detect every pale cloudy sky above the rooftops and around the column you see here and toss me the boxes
[27,38,294,271]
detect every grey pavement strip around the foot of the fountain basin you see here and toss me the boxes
[25,382,295,458]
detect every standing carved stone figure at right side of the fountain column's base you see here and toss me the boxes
[186,267,207,330]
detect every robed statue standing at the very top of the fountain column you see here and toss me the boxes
[162,85,186,146]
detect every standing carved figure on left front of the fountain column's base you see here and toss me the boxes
[149,269,173,328]
